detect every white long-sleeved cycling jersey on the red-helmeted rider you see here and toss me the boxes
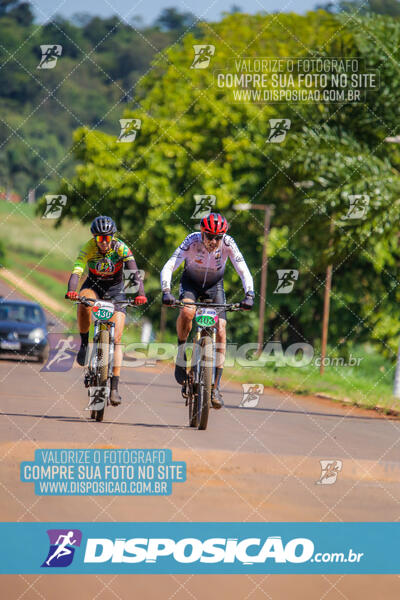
[161,232,253,293]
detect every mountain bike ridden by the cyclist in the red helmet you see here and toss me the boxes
[172,301,242,430]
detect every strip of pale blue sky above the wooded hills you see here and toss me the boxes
[30,0,323,24]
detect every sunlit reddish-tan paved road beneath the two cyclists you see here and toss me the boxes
[0,278,400,600]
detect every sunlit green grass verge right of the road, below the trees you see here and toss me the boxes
[224,345,400,413]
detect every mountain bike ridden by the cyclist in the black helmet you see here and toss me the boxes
[66,296,137,422]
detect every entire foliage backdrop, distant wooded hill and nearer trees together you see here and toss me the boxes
[0,0,400,359]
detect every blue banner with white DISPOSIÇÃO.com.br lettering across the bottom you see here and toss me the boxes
[0,522,400,574]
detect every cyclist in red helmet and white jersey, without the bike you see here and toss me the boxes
[161,213,254,408]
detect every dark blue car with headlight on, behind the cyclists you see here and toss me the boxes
[0,297,49,362]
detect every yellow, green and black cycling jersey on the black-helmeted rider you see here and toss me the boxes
[68,238,144,296]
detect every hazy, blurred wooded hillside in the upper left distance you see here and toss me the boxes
[0,8,173,197]
